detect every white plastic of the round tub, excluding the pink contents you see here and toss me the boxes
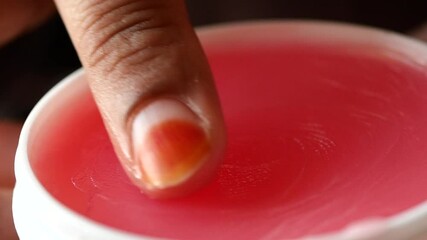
[13,22,427,240]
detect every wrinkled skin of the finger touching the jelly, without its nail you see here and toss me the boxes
[56,0,225,195]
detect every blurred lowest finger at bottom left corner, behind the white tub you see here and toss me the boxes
[0,188,19,240]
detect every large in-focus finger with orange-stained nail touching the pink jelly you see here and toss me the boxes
[56,0,225,197]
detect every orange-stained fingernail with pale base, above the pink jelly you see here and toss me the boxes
[132,99,210,190]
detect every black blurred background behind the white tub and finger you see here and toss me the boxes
[0,0,427,120]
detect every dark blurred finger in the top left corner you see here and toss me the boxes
[0,0,54,46]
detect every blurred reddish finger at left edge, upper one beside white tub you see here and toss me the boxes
[0,121,22,187]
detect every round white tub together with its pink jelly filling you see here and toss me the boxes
[13,21,427,240]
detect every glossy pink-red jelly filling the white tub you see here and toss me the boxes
[31,45,427,240]
